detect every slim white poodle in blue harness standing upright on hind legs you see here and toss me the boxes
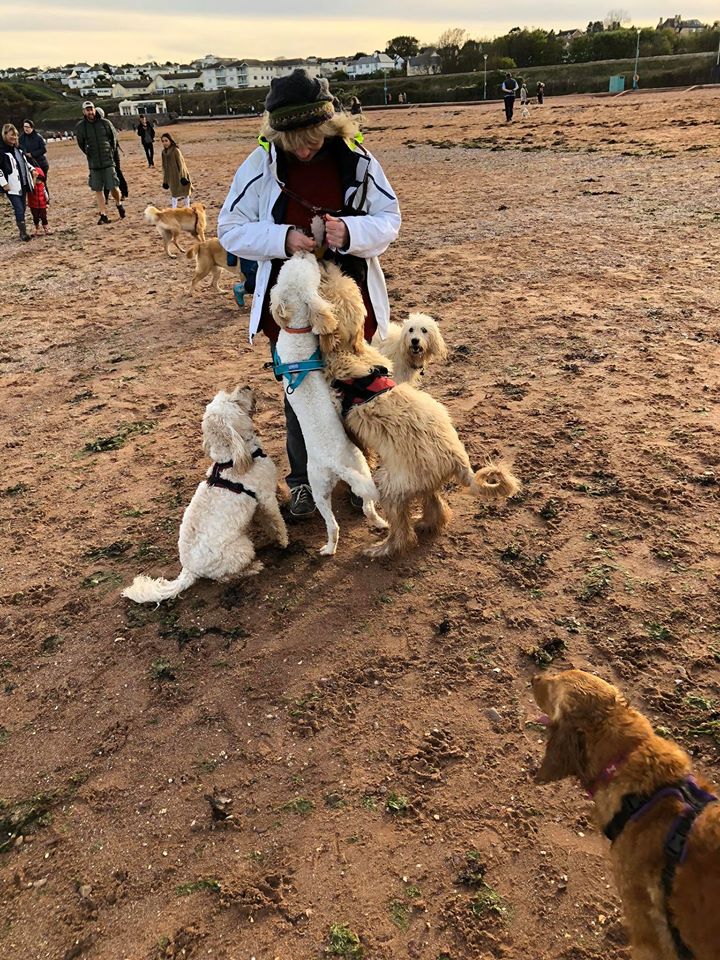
[270,254,387,556]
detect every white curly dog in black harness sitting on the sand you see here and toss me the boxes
[122,387,288,603]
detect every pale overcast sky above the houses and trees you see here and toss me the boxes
[0,0,719,67]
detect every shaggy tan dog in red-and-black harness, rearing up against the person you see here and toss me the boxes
[320,264,520,557]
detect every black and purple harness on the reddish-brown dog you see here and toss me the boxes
[603,777,718,960]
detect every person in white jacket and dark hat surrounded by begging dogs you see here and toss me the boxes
[218,69,400,519]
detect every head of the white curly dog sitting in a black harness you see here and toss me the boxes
[202,387,255,473]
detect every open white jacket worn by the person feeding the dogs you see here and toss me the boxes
[218,140,400,342]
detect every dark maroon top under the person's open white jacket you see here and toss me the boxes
[260,148,377,343]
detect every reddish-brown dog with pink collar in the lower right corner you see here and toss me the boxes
[533,670,720,960]
